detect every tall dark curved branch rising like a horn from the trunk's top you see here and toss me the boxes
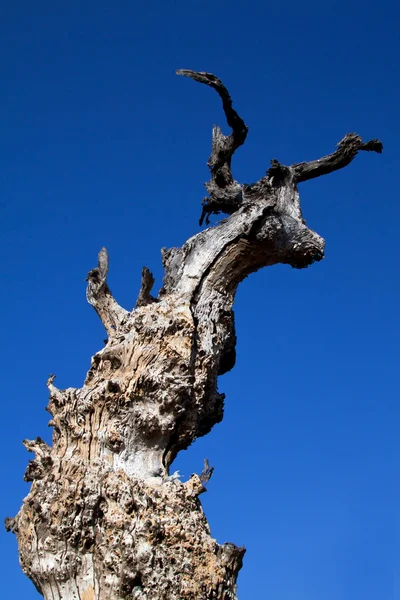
[176,69,248,225]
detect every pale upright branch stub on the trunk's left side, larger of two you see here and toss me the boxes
[86,248,129,337]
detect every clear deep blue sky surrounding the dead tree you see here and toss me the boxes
[0,0,400,600]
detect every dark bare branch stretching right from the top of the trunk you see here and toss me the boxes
[291,133,383,183]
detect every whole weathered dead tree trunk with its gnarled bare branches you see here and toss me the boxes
[6,70,382,600]
